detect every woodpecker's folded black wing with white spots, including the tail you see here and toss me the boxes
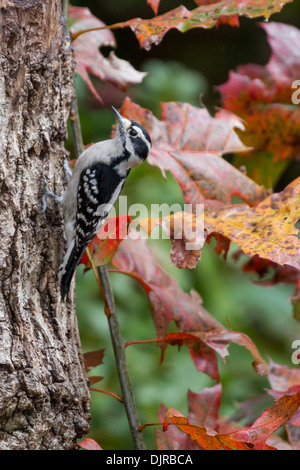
[60,163,125,298]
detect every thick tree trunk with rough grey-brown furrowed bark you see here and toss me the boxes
[0,0,90,450]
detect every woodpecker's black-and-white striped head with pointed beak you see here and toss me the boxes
[112,106,151,168]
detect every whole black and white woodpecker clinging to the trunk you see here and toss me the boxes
[59,108,151,298]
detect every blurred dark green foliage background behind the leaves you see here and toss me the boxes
[67,0,300,450]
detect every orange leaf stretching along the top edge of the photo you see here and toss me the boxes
[113,0,292,50]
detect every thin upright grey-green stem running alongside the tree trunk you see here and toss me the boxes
[64,0,146,450]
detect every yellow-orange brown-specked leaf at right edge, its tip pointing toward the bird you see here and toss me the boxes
[136,178,300,270]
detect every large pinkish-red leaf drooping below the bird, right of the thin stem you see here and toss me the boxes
[111,238,221,380]
